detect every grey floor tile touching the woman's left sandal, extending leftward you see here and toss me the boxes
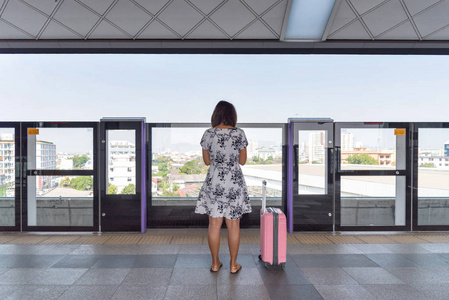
[170,268,216,286]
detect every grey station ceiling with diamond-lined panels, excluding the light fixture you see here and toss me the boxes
[0,0,449,54]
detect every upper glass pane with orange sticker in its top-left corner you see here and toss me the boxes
[27,128,94,170]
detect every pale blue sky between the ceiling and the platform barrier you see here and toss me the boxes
[0,54,449,123]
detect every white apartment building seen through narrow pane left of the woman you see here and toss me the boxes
[108,141,136,193]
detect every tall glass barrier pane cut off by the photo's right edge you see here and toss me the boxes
[418,128,449,225]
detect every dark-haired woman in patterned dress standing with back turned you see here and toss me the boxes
[195,101,251,274]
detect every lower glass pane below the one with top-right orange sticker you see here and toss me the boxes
[340,176,406,226]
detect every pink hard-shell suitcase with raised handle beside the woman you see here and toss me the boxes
[259,180,287,269]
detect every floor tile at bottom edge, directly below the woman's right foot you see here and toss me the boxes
[217,285,270,300]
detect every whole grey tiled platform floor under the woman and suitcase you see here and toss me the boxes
[0,230,449,300]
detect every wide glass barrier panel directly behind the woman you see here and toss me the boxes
[151,127,282,208]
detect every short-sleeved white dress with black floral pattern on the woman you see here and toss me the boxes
[195,127,251,219]
